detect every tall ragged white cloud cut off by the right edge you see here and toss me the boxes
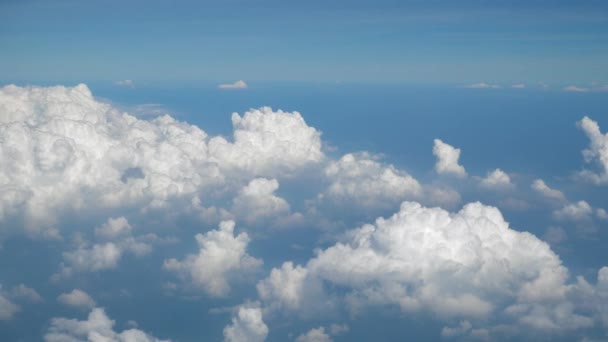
[578,116,608,185]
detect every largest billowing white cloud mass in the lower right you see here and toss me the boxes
[258,202,593,331]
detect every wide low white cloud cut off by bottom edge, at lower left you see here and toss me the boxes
[44,308,168,342]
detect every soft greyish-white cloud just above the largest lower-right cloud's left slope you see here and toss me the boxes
[323,153,422,207]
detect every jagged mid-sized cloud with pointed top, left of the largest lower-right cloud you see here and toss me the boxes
[163,221,262,297]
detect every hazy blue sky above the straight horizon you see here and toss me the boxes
[0,0,608,85]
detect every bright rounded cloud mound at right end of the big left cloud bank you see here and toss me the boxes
[209,107,324,176]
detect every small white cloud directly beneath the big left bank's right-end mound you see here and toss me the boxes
[232,178,290,223]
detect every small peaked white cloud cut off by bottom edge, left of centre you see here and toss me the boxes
[224,306,268,342]
